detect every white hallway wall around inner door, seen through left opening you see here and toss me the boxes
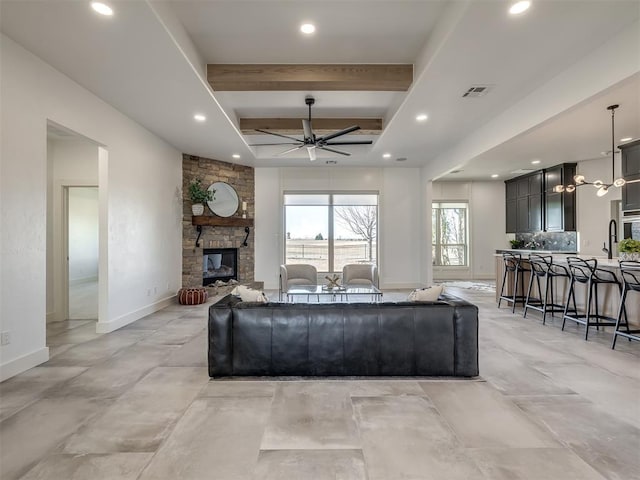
[47,136,98,321]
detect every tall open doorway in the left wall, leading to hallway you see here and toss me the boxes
[46,120,100,346]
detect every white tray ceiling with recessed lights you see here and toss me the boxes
[0,0,640,180]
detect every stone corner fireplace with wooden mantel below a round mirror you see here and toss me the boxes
[182,154,255,287]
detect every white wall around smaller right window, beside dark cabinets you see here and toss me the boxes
[432,182,507,279]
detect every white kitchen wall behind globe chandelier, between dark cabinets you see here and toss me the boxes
[576,155,622,257]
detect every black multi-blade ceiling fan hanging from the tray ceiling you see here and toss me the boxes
[249,97,373,161]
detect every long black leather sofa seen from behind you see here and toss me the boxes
[209,294,478,377]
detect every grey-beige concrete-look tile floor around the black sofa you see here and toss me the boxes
[0,288,640,480]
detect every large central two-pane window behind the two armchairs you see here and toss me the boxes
[284,193,378,272]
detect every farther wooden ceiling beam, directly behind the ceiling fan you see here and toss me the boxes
[240,118,382,135]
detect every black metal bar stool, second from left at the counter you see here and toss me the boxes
[523,253,577,325]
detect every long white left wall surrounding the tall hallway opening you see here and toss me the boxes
[0,35,182,380]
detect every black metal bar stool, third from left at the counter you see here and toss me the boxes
[562,257,626,340]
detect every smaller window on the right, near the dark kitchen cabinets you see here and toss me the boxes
[431,202,469,266]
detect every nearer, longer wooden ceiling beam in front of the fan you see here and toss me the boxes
[207,64,413,92]
